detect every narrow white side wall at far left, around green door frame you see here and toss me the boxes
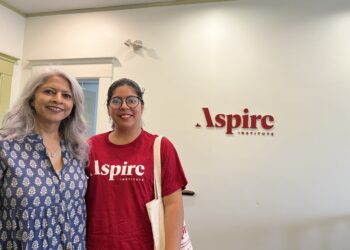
[0,5,25,104]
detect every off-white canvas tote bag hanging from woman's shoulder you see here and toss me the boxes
[146,136,193,250]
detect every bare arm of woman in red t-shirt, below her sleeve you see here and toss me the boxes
[163,189,184,250]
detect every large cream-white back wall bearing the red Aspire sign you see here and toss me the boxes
[24,0,350,250]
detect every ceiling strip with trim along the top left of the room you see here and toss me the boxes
[0,0,230,16]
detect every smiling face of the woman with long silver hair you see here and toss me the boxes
[31,76,74,126]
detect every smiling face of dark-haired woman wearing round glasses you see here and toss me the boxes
[108,85,143,132]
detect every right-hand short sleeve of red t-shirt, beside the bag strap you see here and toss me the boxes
[161,137,187,196]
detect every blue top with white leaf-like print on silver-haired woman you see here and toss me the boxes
[0,134,87,250]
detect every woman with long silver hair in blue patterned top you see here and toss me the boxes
[0,68,87,249]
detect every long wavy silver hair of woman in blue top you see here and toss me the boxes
[0,67,88,163]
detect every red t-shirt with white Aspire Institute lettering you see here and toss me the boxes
[86,131,187,250]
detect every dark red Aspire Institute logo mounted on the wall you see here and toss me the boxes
[195,107,275,136]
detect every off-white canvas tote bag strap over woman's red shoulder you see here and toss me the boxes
[153,136,163,199]
